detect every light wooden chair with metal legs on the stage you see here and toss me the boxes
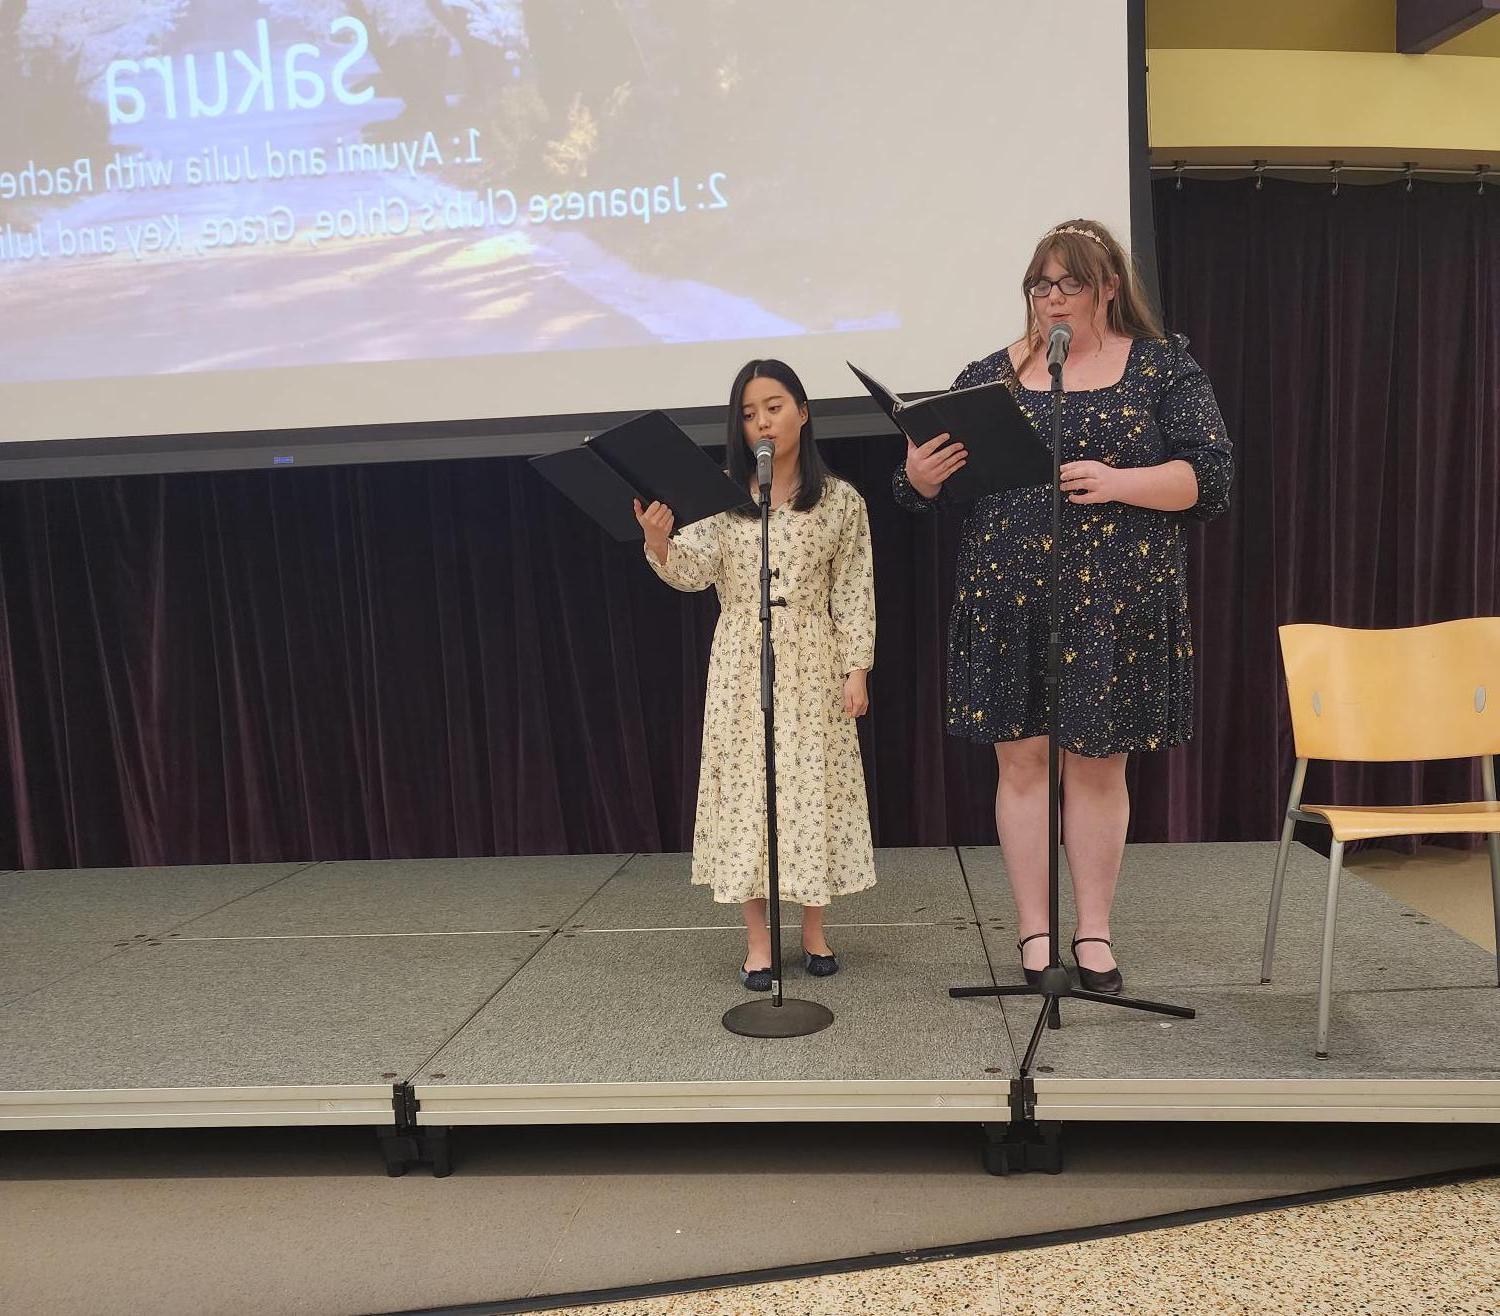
[1260,617,1500,1058]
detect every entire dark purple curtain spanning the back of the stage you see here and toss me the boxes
[0,182,1500,867]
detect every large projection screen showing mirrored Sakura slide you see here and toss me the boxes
[0,0,1140,476]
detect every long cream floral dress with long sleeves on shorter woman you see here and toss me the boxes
[647,476,875,905]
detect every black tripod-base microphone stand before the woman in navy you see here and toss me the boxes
[948,335,1197,1175]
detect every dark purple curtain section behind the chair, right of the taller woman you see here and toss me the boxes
[1152,180,1500,843]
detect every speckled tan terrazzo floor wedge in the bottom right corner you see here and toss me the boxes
[555,1179,1500,1316]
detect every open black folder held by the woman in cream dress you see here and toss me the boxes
[531,411,755,543]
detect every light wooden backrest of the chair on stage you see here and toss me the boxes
[1280,617,1500,762]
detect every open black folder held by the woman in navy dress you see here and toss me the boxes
[849,362,1052,500]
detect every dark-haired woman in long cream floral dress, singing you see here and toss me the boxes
[636,360,875,992]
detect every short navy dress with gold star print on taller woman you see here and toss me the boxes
[894,335,1232,758]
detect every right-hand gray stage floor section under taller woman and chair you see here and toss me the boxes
[960,845,1500,1080]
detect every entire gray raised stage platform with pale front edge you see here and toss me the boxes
[0,843,1500,1127]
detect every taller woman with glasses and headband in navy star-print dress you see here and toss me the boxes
[894,219,1232,992]
